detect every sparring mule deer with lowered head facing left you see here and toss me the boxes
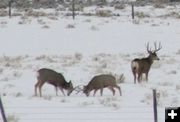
[83,74,122,96]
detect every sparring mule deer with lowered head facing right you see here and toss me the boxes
[35,68,73,97]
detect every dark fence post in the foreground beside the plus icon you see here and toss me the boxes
[153,89,158,122]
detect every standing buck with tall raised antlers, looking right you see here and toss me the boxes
[131,43,162,83]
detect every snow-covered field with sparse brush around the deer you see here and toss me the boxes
[0,3,180,122]
